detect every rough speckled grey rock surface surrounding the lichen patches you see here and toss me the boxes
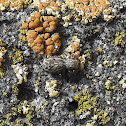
[0,0,126,126]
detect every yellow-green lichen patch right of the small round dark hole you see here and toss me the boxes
[74,89,110,125]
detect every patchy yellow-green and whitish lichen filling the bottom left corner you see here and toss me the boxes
[0,100,35,126]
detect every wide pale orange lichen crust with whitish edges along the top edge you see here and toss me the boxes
[65,0,110,24]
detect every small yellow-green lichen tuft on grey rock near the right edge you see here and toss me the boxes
[115,32,126,47]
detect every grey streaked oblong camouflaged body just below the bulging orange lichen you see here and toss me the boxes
[42,56,80,73]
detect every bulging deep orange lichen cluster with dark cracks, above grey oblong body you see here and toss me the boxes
[21,11,61,56]
